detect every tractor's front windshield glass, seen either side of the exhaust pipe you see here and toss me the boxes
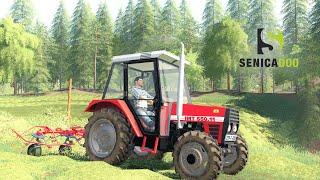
[159,60,191,103]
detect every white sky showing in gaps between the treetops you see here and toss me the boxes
[0,0,283,27]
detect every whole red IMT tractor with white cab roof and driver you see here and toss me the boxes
[84,47,248,179]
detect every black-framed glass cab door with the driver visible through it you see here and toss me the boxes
[125,60,159,133]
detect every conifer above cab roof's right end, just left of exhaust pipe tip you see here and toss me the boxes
[160,0,180,52]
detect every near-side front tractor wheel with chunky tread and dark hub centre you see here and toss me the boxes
[173,131,221,179]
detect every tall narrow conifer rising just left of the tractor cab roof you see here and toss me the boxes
[94,3,113,89]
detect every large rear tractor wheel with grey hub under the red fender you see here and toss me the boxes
[85,107,132,165]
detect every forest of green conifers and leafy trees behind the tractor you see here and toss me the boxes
[0,0,320,142]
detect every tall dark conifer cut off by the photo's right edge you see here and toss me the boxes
[294,1,320,145]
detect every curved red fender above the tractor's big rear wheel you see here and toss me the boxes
[85,99,143,137]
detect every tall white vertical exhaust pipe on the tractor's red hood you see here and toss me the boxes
[176,43,185,129]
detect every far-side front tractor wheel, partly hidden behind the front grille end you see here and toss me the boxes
[223,135,248,175]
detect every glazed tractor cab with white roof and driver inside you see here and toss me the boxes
[102,51,191,134]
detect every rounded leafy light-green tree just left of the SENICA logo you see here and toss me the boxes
[200,18,248,90]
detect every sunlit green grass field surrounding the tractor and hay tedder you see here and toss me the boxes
[0,91,320,179]
